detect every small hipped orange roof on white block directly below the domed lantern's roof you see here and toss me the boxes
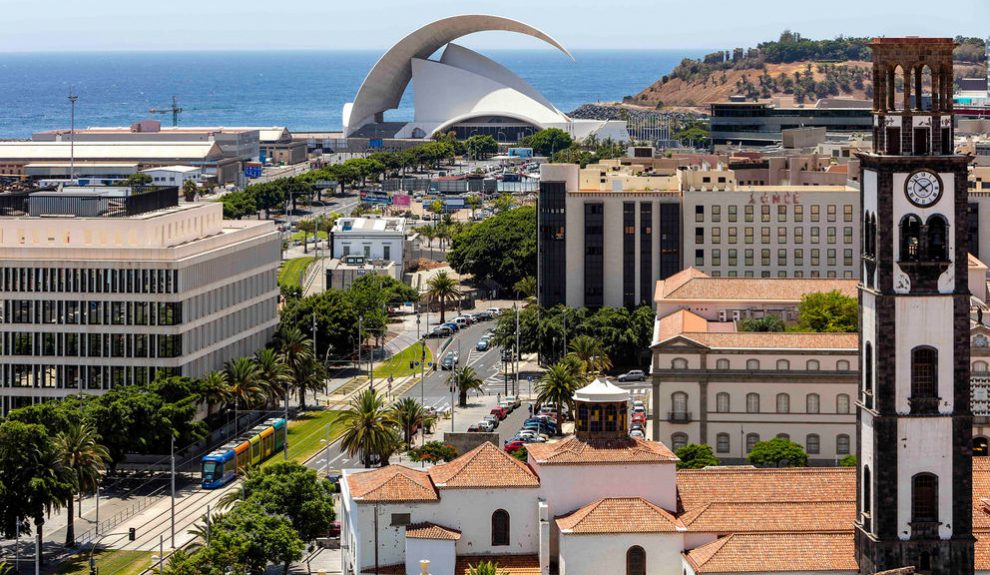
[557,497,684,534]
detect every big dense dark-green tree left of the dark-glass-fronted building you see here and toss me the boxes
[447,206,536,287]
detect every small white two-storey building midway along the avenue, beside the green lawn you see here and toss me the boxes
[331,217,411,277]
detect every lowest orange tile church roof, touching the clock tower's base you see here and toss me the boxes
[685,530,858,573]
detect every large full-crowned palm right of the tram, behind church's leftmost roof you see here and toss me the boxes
[330,389,395,467]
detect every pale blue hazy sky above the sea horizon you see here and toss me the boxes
[0,0,990,52]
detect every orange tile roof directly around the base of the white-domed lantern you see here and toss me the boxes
[526,436,680,465]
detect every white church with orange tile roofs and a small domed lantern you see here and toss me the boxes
[340,380,990,575]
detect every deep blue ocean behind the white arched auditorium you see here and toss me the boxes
[0,50,704,138]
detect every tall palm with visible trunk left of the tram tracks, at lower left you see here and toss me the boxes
[54,423,110,547]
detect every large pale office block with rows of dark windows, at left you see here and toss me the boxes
[0,187,281,413]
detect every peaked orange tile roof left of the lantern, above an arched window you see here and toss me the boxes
[428,441,540,489]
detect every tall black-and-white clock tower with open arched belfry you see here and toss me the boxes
[856,38,974,575]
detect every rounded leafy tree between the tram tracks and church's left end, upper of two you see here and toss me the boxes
[241,461,334,541]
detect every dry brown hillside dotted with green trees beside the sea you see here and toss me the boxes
[625,31,986,109]
